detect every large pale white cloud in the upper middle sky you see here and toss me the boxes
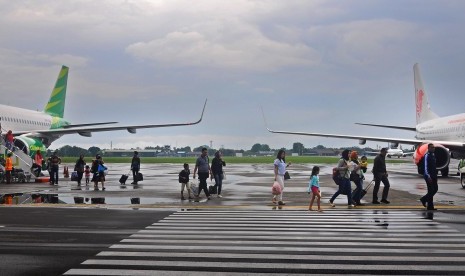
[126,30,319,71]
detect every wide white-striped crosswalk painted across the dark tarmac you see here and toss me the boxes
[65,210,465,275]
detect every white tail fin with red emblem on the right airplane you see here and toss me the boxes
[413,63,439,125]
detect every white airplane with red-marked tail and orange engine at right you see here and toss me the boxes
[265,63,465,177]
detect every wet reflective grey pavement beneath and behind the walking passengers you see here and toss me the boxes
[0,163,465,209]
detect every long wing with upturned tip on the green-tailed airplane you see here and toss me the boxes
[15,100,207,137]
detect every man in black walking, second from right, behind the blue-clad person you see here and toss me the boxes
[372,148,391,204]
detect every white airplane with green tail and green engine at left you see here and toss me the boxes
[0,65,207,156]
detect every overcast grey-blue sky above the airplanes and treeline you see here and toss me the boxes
[0,0,465,149]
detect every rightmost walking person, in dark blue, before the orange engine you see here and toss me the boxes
[420,143,438,210]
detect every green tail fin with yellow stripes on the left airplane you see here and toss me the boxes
[44,65,69,118]
